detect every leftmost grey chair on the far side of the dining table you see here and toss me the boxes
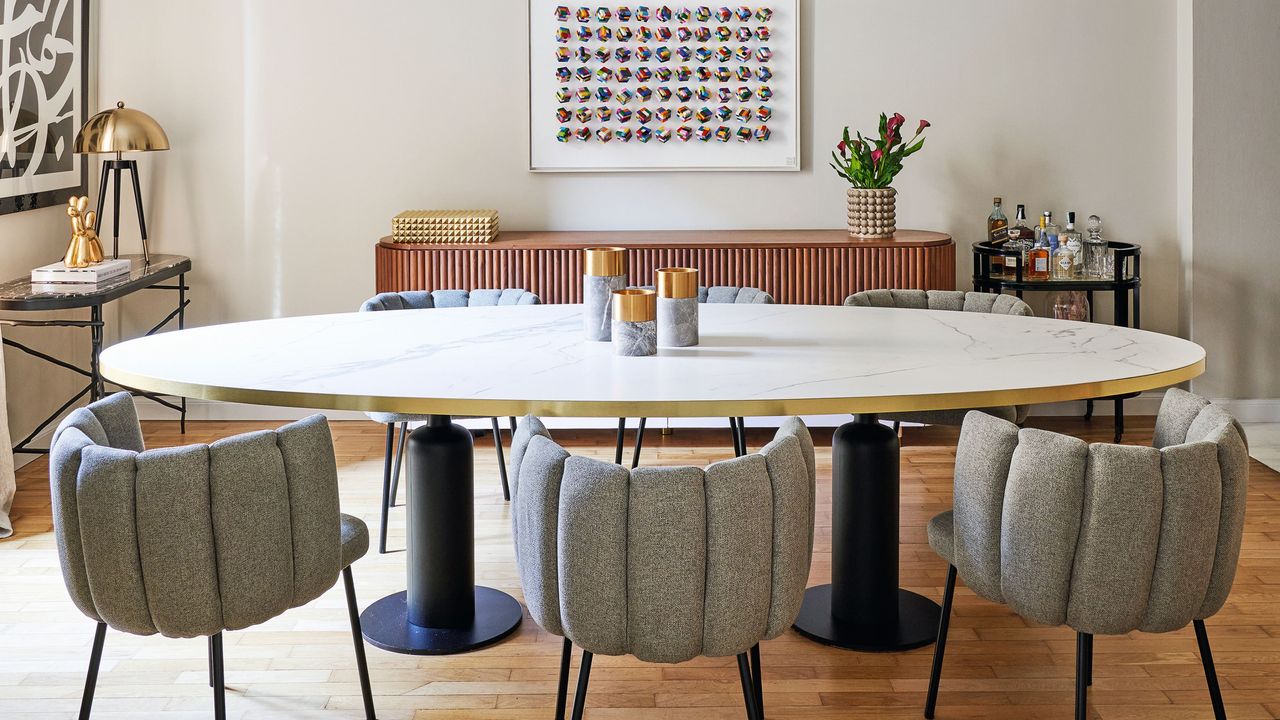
[360,288,539,553]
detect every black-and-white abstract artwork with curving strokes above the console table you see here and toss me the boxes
[0,0,88,214]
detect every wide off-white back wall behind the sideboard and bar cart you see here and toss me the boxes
[99,0,1180,332]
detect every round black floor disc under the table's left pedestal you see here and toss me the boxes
[360,585,521,655]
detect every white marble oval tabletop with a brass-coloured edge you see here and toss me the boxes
[101,305,1204,416]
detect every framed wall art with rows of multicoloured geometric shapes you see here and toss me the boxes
[529,0,800,172]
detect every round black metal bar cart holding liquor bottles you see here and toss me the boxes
[973,241,1142,442]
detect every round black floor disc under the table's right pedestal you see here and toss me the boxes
[795,585,942,652]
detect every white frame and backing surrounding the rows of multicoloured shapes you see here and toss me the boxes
[529,0,800,173]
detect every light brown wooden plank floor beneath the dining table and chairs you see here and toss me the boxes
[0,418,1280,720]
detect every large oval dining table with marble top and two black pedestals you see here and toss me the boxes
[101,305,1204,655]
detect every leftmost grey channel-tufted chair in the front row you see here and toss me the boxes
[49,392,374,720]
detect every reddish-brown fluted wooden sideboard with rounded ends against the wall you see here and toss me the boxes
[375,229,956,305]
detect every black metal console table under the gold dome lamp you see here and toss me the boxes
[0,255,191,454]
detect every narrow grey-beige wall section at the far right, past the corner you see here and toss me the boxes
[1189,0,1280,397]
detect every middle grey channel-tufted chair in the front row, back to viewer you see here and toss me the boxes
[511,416,815,720]
